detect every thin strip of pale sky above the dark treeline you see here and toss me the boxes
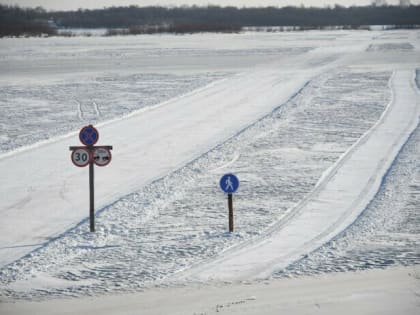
[0,0,420,10]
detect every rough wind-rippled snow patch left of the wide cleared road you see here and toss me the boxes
[0,73,226,152]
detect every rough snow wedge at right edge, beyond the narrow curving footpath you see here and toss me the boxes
[274,69,420,277]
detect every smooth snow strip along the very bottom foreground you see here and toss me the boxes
[0,266,420,315]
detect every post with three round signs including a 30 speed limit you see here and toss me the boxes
[70,125,112,232]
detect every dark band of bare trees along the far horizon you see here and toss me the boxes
[0,5,420,36]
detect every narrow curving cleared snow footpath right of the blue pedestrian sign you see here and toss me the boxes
[180,70,420,281]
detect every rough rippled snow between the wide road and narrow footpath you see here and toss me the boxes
[2,69,390,299]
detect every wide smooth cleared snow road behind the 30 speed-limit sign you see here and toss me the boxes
[0,58,334,266]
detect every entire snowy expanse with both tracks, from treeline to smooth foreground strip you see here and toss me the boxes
[0,31,420,314]
